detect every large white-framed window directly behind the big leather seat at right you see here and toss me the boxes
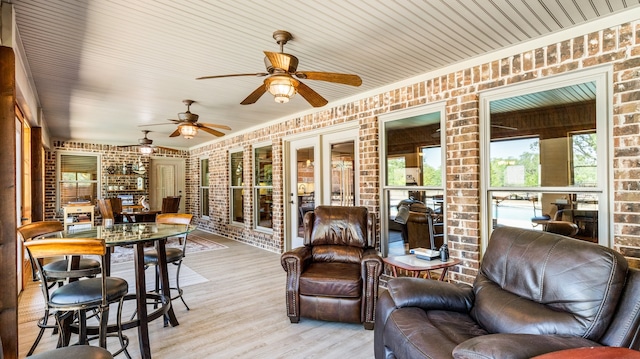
[480,69,610,247]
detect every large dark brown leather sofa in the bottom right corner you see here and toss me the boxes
[374,227,640,359]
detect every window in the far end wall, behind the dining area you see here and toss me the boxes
[58,153,99,207]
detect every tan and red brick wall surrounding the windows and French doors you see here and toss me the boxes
[46,22,640,283]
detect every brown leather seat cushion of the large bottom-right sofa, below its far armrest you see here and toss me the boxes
[384,307,487,358]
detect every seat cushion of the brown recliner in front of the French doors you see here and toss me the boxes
[300,262,362,298]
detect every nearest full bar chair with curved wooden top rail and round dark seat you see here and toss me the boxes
[25,238,131,358]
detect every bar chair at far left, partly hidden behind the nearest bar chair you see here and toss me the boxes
[18,221,100,356]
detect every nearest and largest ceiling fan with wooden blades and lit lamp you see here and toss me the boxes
[196,30,362,107]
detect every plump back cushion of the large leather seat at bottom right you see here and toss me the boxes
[471,227,628,341]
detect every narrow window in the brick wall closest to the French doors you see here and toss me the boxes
[253,146,273,229]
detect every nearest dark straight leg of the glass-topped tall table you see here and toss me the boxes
[134,242,151,359]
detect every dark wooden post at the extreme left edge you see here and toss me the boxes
[0,46,18,359]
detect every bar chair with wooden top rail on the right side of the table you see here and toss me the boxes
[144,213,193,310]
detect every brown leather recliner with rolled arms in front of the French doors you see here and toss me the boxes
[281,206,383,329]
